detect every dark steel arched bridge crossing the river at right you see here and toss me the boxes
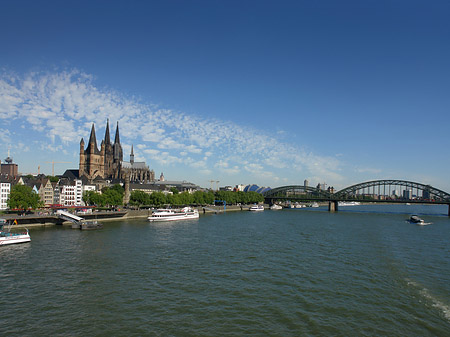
[263,179,450,216]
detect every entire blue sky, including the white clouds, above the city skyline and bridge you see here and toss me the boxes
[0,0,450,191]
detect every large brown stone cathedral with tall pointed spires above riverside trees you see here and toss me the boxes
[79,120,155,183]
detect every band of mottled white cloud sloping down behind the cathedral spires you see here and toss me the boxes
[0,70,342,185]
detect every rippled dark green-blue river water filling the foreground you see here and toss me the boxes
[0,205,450,336]
